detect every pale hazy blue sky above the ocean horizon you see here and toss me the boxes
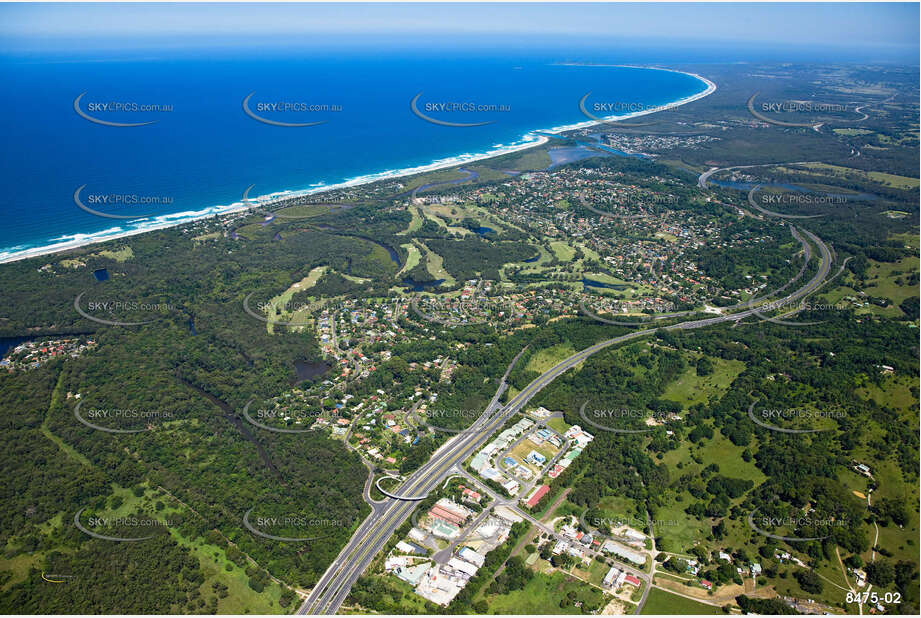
[0,3,919,59]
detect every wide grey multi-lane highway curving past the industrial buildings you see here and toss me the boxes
[297,224,833,614]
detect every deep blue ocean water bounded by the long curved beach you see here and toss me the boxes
[0,42,706,259]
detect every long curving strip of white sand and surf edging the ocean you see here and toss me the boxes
[0,63,717,264]
